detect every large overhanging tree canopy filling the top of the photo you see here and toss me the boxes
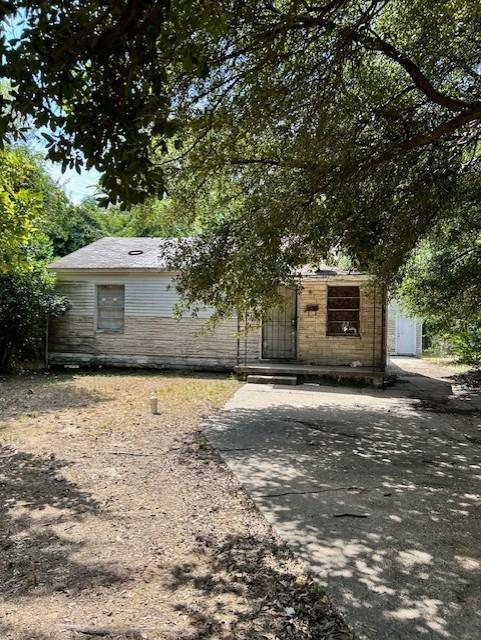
[0,0,481,313]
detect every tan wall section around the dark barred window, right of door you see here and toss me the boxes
[297,276,385,368]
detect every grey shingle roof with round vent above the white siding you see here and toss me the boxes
[49,237,177,271]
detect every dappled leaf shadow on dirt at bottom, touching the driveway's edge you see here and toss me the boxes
[168,536,352,640]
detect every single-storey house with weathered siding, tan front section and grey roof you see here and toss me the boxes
[49,238,386,383]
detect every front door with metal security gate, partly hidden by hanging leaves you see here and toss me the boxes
[262,287,297,360]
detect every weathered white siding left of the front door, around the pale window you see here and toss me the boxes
[49,274,259,369]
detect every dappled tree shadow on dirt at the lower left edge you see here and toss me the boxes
[0,446,126,598]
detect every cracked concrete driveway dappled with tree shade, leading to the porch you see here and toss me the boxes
[205,359,481,640]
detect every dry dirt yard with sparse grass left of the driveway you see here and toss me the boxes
[0,370,351,640]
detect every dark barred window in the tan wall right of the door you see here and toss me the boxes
[327,287,360,336]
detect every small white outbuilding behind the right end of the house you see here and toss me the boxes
[387,300,423,358]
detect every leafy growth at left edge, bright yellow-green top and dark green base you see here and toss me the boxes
[0,148,68,371]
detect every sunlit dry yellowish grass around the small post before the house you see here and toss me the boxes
[0,369,239,440]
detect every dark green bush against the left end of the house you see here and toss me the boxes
[0,266,68,371]
